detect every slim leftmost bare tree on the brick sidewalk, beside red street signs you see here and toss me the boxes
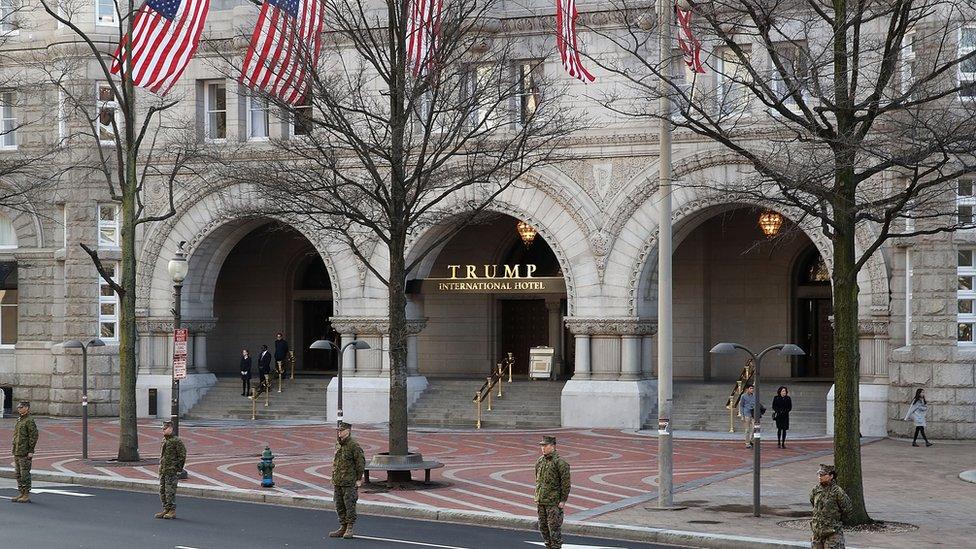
[36,0,210,461]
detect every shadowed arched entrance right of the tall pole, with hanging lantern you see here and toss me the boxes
[673,207,816,381]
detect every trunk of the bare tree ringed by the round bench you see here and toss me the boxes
[388,226,410,481]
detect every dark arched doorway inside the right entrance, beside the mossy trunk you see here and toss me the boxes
[794,247,834,378]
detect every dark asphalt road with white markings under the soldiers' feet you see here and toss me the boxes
[0,479,669,549]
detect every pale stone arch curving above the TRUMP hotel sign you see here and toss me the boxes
[407,182,599,316]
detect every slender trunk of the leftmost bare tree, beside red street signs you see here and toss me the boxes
[117,150,139,461]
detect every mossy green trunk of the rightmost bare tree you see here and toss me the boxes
[833,210,871,524]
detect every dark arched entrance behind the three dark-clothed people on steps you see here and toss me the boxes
[207,222,337,374]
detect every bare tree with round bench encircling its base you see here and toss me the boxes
[212,0,582,474]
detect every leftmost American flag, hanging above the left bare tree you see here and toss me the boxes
[112,0,210,95]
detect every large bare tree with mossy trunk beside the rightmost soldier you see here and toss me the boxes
[594,0,976,524]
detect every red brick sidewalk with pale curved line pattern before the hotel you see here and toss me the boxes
[0,419,831,521]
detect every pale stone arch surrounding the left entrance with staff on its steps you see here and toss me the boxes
[136,185,359,319]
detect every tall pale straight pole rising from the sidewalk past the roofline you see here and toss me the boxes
[657,0,674,509]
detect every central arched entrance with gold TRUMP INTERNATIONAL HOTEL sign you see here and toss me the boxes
[410,213,574,377]
